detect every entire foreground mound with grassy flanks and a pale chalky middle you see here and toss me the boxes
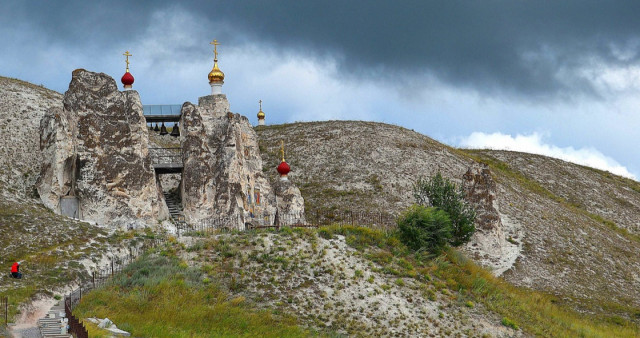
[75,226,640,337]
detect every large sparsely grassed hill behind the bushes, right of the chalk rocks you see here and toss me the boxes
[256,121,640,320]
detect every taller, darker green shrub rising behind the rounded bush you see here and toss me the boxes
[413,172,476,246]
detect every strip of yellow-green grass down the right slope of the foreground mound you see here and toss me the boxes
[320,226,640,337]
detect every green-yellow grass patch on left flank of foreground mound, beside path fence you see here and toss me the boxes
[74,252,308,337]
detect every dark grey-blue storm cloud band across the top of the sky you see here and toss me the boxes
[3,0,640,97]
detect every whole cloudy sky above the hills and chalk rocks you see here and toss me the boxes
[0,0,640,179]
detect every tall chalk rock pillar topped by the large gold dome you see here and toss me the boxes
[180,95,276,229]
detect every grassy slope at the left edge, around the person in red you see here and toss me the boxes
[0,199,107,320]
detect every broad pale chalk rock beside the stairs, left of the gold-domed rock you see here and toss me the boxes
[37,69,168,228]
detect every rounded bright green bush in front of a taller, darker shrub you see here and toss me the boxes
[398,204,452,253]
